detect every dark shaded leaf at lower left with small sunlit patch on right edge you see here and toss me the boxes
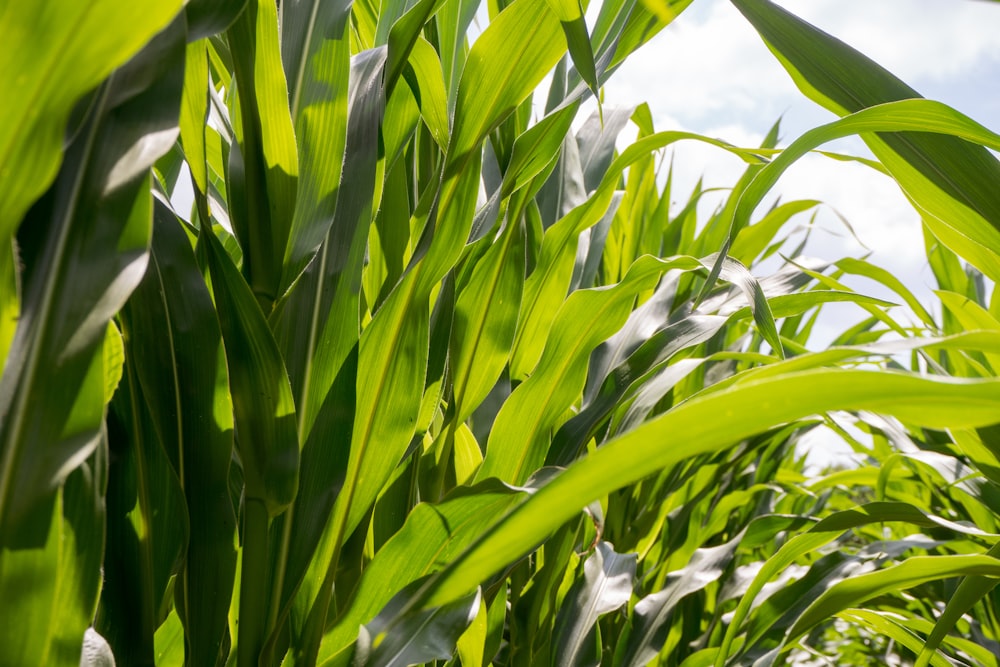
[115,200,236,664]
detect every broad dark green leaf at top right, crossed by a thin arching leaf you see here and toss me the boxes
[732,0,1000,280]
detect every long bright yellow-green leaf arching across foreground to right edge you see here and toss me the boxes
[421,369,1000,606]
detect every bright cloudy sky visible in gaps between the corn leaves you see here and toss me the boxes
[584,0,1000,470]
